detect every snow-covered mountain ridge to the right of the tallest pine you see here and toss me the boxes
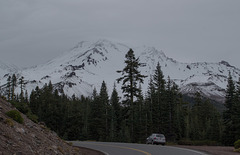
[140,48,240,102]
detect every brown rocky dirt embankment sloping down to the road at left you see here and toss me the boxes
[0,98,100,155]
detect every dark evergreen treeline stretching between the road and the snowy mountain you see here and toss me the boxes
[3,49,240,145]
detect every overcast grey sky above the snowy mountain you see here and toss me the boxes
[0,0,240,68]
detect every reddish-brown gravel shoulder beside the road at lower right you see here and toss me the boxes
[175,145,240,155]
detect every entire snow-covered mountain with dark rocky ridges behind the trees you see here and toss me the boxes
[0,40,240,101]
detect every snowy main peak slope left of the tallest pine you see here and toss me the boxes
[16,40,129,97]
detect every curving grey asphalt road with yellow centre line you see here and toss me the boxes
[72,141,206,155]
